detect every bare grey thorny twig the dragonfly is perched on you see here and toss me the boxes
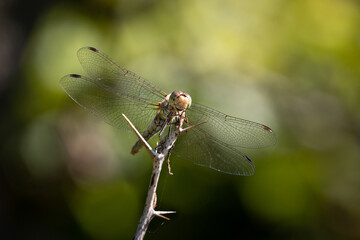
[122,114,205,240]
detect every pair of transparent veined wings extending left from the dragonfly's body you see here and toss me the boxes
[60,47,166,131]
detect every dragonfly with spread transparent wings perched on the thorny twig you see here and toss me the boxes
[60,47,276,176]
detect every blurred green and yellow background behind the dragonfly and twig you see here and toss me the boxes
[0,0,360,239]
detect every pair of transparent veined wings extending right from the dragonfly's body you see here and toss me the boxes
[174,104,276,176]
